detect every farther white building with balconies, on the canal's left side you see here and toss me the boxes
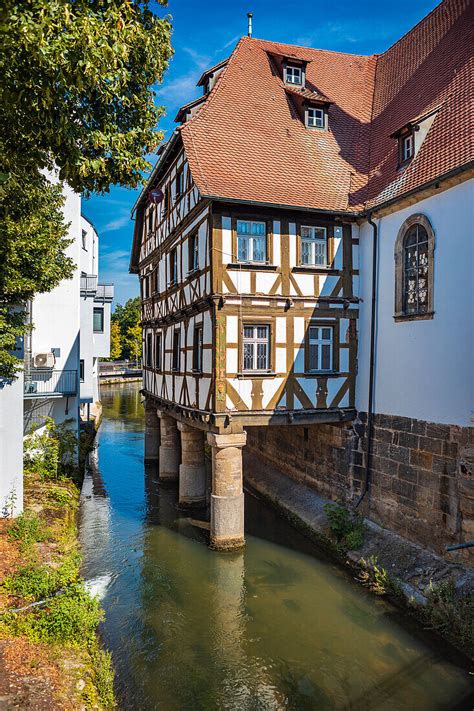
[79,216,114,419]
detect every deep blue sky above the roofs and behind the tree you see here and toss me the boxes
[82,0,438,304]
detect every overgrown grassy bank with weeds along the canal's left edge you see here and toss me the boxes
[0,422,115,709]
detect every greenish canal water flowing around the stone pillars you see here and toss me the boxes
[80,384,472,711]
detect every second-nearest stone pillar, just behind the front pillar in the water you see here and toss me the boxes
[178,422,206,507]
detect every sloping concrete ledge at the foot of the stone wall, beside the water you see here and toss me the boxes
[244,450,474,604]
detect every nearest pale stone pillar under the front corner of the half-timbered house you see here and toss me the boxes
[207,432,247,551]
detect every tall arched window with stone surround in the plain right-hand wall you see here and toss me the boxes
[395,214,435,320]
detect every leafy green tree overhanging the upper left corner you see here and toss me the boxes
[0,0,171,378]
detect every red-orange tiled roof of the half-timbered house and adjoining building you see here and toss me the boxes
[172,0,474,212]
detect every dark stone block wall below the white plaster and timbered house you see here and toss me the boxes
[247,413,474,562]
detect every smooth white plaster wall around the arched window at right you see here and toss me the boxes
[356,180,474,426]
